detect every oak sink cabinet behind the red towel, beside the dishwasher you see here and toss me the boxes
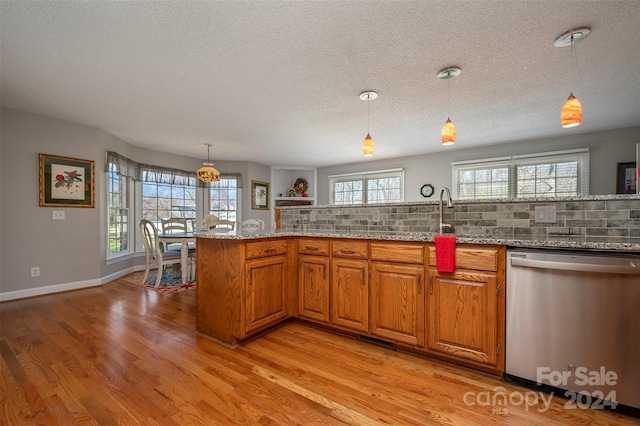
[427,245,505,371]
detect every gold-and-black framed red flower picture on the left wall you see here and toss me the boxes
[39,153,95,208]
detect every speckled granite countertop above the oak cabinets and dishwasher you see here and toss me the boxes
[198,230,640,253]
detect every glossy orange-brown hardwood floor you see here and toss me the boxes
[0,280,640,425]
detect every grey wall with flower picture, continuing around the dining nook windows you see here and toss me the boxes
[0,108,270,300]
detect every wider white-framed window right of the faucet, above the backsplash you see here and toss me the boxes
[452,149,589,200]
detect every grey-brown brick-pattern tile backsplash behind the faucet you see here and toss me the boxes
[281,195,640,238]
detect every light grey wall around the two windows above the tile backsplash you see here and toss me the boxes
[318,127,640,205]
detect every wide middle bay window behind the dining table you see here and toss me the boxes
[142,167,196,229]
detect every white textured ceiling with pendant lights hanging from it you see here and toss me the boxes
[0,0,640,167]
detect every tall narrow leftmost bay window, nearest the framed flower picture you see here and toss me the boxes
[107,162,129,256]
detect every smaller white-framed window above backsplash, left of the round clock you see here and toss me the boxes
[329,169,404,205]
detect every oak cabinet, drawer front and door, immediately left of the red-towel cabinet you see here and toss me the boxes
[370,242,426,347]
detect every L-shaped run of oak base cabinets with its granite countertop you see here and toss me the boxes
[197,232,640,375]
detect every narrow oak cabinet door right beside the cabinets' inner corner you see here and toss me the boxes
[298,255,329,324]
